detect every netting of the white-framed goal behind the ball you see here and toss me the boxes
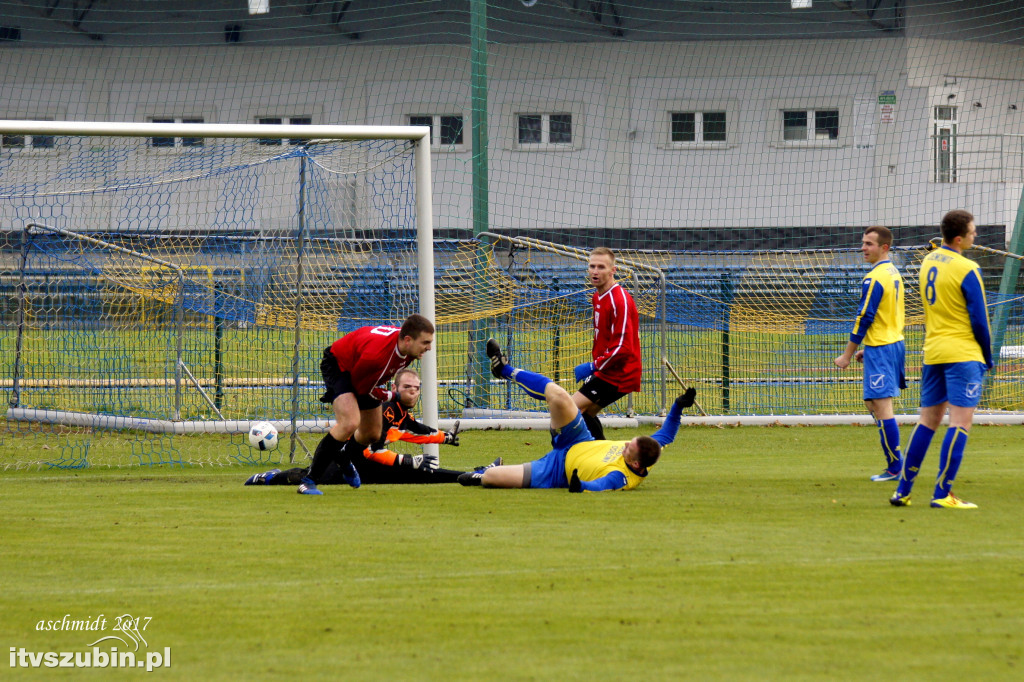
[0,131,419,466]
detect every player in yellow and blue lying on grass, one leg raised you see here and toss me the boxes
[459,339,696,493]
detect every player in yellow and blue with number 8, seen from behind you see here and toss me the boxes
[889,210,993,509]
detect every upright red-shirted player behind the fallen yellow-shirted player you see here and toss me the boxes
[572,247,643,440]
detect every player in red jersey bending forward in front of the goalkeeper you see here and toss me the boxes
[299,314,434,495]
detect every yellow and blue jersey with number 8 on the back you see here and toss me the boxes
[920,246,992,369]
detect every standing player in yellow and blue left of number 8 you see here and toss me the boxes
[833,225,906,481]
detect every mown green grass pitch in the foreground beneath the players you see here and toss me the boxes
[0,426,1024,680]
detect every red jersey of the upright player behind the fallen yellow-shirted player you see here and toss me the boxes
[591,284,643,393]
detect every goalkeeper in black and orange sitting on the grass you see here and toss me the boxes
[246,368,502,485]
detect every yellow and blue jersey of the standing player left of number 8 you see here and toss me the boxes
[850,260,905,346]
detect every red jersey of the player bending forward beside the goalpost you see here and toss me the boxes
[323,326,414,395]
